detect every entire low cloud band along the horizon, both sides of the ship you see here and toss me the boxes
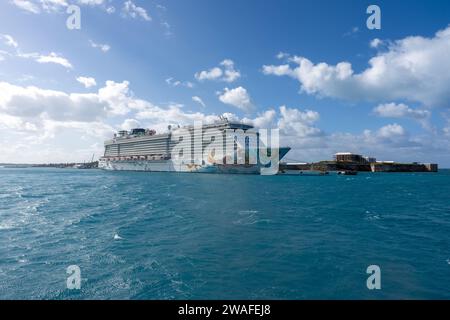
[0,81,450,162]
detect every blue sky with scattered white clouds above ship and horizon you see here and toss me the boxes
[0,0,450,167]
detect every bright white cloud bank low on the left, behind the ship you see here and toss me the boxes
[0,81,274,162]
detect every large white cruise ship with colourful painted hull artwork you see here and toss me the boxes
[99,118,290,174]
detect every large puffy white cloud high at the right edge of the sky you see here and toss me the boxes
[263,26,450,107]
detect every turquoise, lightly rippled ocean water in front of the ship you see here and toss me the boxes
[0,168,450,299]
